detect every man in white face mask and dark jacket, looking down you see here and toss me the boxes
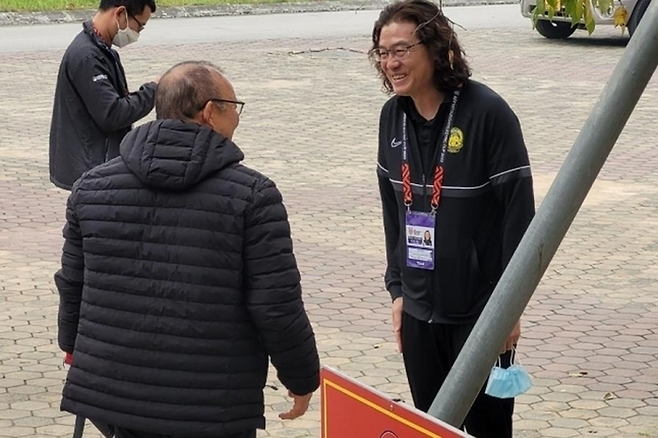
[50,0,157,190]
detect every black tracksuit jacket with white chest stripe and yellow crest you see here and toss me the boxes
[377,81,534,324]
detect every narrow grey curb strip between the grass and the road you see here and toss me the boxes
[0,0,517,26]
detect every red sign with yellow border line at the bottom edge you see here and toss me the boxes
[322,367,470,438]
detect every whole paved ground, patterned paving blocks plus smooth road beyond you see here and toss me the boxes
[0,7,658,438]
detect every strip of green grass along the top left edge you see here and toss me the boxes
[0,0,302,12]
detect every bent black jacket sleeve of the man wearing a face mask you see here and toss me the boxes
[68,55,157,133]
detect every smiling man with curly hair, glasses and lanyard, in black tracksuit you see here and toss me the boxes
[371,0,534,438]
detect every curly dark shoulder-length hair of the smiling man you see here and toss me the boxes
[370,0,471,93]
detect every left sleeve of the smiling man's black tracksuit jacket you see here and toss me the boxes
[377,111,402,300]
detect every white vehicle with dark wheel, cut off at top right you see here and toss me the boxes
[521,0,651,38]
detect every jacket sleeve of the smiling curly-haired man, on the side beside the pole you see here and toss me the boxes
[486,99,535,269]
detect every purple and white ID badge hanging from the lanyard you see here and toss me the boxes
[406,211,435,269]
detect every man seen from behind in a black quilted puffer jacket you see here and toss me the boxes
[55,62,319,438]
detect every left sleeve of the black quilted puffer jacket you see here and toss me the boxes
[55,186,84,353]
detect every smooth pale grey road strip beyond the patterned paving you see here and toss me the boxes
[0,5,530,53]
